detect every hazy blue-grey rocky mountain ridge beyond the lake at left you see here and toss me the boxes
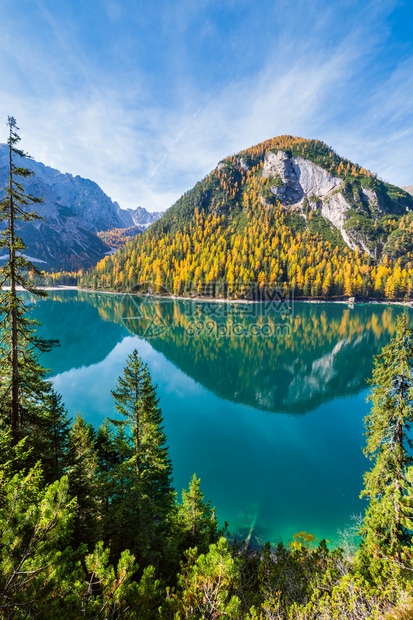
[0,144,161,269]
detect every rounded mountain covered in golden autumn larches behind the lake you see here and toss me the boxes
[80,136,413,298]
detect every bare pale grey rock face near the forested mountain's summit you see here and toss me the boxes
[262,150,405,255]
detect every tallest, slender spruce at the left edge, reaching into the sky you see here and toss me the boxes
[0,117,55,445]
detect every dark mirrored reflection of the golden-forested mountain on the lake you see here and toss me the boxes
[36,291,411,414]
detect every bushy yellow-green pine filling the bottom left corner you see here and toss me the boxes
[0,431,83,619]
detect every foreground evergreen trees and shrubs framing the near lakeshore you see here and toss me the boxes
[0,118,413,620]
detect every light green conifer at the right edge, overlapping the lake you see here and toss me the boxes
[361,314,413,560]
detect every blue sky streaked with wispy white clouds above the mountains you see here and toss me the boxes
[0,0,413,211]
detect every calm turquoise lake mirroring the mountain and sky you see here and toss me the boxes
[30,291,412,543]
